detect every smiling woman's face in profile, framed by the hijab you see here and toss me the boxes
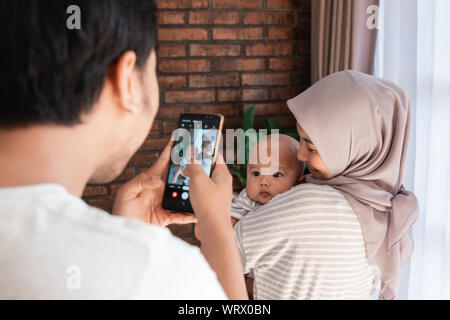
[297,123,331,180]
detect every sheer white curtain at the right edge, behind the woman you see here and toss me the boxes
[375,0,450,299]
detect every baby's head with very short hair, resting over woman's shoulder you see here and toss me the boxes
[247,134,304,204]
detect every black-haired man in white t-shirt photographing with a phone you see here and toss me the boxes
[0,0,246,299]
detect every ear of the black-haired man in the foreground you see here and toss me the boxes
[107,51,140,112]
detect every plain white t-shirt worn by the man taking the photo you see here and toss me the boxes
[0,184,226,299]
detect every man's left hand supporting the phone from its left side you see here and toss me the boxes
[112,142,197,226]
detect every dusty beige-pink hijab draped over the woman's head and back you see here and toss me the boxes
[287,71,418,299]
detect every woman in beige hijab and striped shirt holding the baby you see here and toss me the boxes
[235,71,418,299]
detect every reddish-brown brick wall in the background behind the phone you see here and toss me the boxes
[83,0,311,244]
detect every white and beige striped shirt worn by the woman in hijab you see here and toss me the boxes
[235,184,378,300]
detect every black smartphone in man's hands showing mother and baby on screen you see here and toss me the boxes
[163,113,224,213]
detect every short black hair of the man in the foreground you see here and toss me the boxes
[0,0,157,128]
